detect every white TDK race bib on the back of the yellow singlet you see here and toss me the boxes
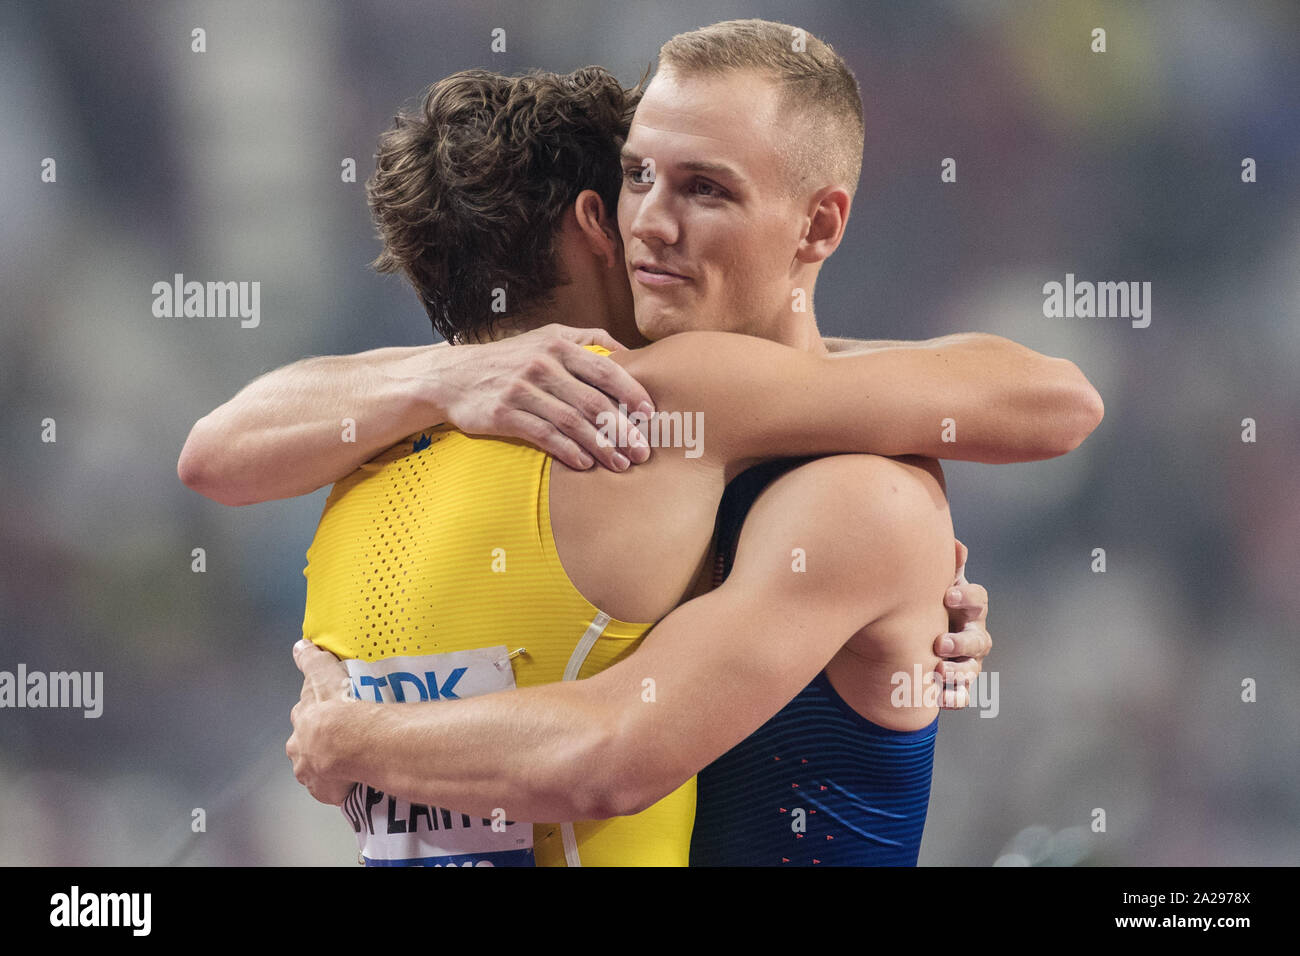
[342,646,534,866]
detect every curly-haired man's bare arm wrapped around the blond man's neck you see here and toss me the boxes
[616,332,1104,464]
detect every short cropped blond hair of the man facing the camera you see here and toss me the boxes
[659,20,863,196]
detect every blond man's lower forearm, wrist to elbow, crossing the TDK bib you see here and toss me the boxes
[327,682,619,822]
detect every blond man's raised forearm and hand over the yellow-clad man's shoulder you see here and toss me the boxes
[177,325,649,505]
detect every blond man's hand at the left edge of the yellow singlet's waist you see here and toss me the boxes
[285,640,355,806]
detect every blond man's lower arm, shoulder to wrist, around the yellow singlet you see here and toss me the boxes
[299,457,953,821]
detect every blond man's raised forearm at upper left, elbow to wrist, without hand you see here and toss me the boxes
[177,346,443,505]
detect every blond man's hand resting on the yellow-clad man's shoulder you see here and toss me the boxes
[434,325,654,471]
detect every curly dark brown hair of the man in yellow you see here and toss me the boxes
[365,66,645,343]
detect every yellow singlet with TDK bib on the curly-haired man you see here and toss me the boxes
[303,346,696,866]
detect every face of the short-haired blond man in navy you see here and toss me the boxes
[619,70,807,339]
